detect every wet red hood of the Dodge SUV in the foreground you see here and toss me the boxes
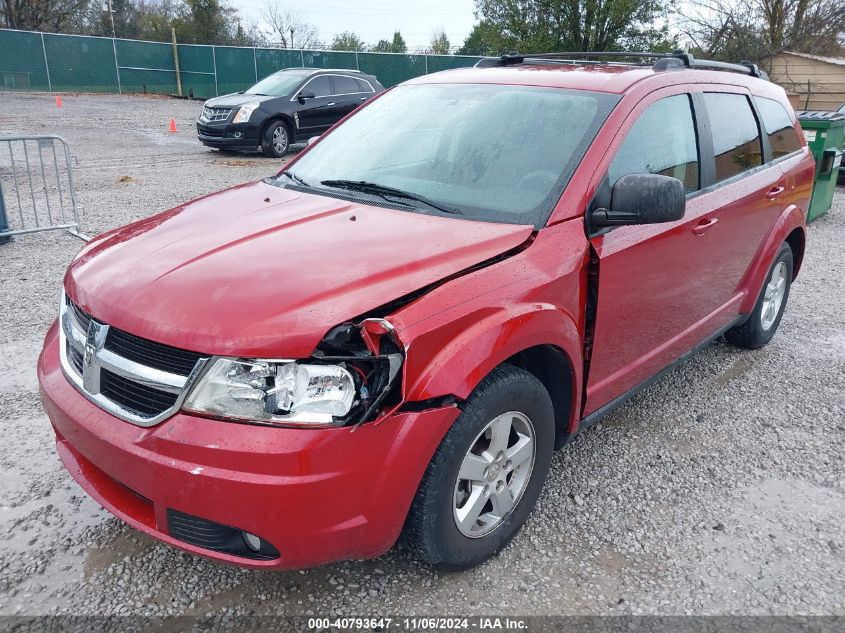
[65,182,533,358]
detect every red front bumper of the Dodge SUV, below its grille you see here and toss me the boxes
[38,325,459,568]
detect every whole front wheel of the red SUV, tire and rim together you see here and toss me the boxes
[403,365,555,570]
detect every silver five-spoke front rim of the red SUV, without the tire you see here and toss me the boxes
[453,411,536,538]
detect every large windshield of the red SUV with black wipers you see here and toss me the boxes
[278,84,618,228]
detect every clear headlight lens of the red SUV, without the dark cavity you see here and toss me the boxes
[182,358,354,426]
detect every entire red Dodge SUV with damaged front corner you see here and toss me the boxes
[38,55,813,569]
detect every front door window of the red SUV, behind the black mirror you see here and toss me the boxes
[607,95,699,193]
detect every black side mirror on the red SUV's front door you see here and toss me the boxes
[590,174,686,228]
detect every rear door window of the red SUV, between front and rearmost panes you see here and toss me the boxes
[704,92,763,181]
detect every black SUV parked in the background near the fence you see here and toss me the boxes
[197,68,384,157]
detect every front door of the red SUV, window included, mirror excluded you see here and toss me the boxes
[584,87,736,414]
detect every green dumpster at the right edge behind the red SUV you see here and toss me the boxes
[796,110,845,222]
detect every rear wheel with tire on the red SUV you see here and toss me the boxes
[725,243,793,349]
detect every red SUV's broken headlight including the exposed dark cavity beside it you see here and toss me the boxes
[182,354,402,427]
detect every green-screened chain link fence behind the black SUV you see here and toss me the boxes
[0,29,479,99]
